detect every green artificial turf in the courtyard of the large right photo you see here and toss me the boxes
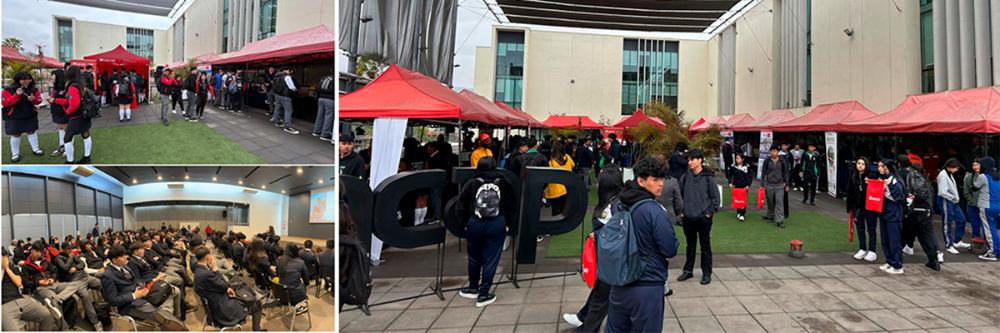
[546,188,857,257]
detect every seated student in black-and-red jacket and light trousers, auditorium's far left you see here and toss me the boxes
[21,243,76,309]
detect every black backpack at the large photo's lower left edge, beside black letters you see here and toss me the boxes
[337,235,374,311]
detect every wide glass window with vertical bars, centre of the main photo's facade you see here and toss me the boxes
[621,39,679,115]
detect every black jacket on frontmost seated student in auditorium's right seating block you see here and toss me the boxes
[194,265,247,326]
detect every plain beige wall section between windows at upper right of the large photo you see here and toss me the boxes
[812,0,920,113]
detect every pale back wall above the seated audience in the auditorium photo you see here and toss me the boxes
[123,182,288,235]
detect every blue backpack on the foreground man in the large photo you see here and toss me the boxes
[597,199,655,286]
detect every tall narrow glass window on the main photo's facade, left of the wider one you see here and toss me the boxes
[493,31,524,109]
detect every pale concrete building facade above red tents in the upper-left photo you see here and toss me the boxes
[52,0,335,65]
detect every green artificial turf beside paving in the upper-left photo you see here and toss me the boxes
[3,121,267,164]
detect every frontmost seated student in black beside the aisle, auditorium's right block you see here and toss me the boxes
[191,246,262,331]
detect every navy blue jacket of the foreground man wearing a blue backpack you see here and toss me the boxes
[619,181,680,285]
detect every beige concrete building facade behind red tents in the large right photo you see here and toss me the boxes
[474,0,932,122]
